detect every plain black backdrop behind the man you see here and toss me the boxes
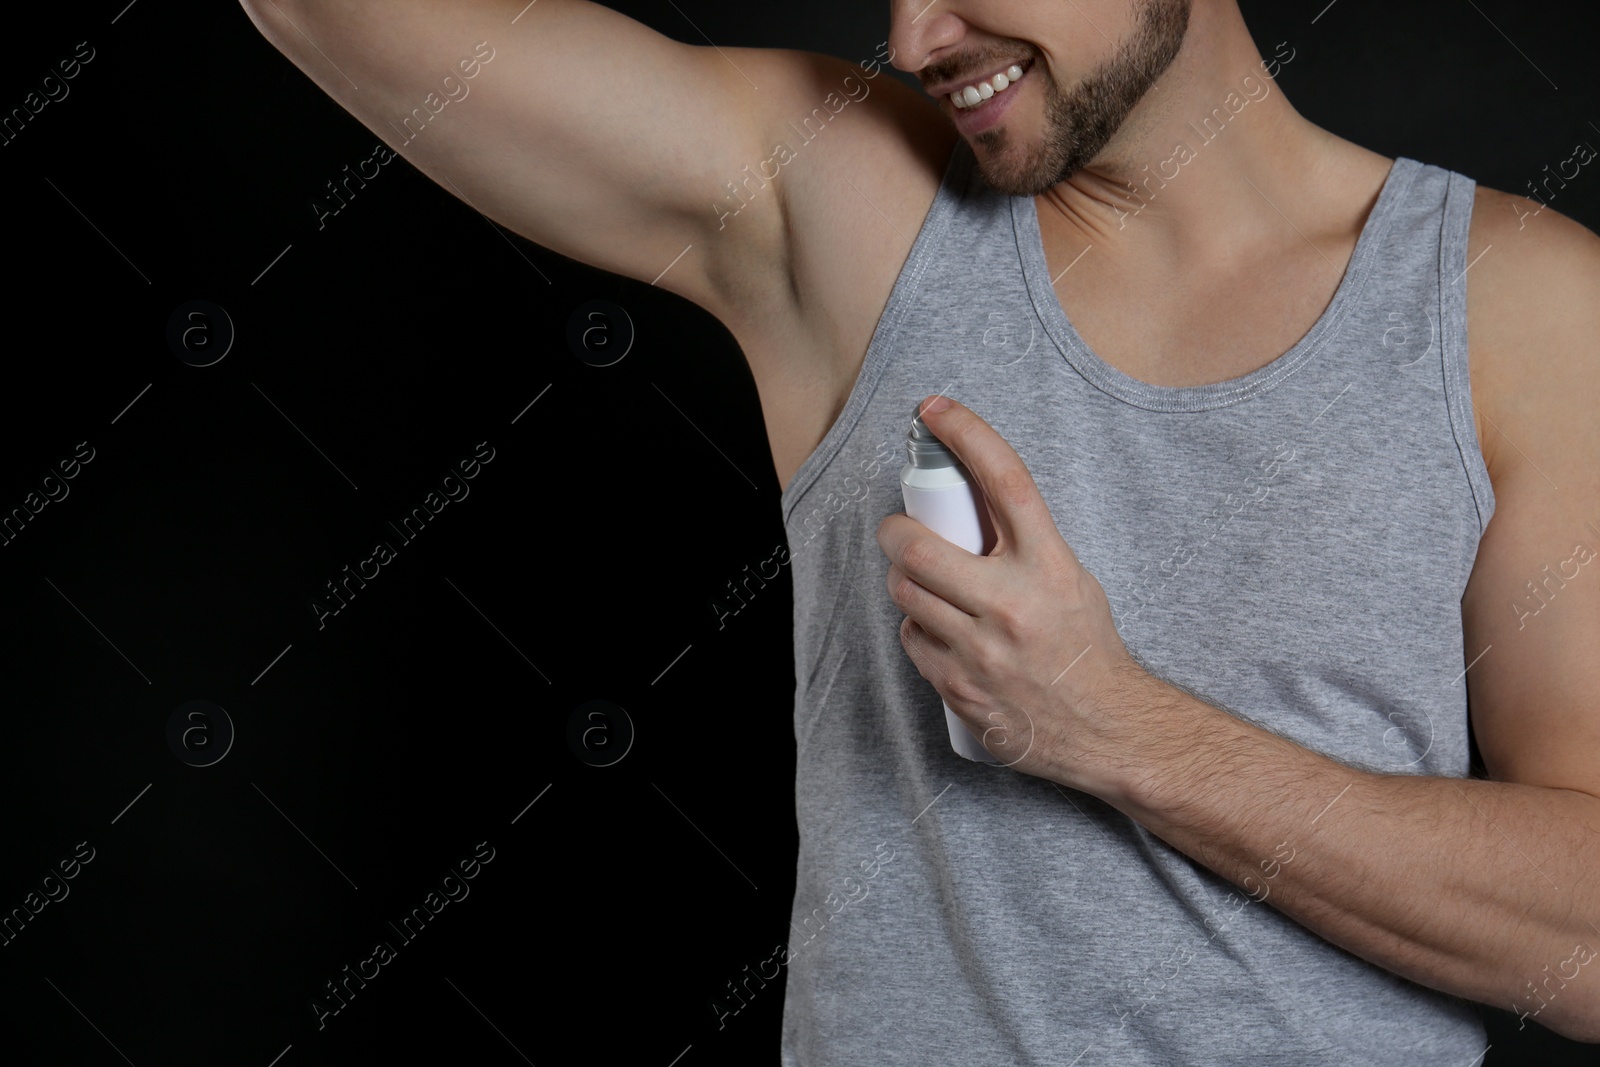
[0,0,1600,1067]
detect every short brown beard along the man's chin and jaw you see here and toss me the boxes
[973,0,1190,197]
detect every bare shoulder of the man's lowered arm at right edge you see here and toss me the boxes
[1466,186,1600,479]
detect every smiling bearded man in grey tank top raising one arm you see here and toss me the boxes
[245,0,1600,1067]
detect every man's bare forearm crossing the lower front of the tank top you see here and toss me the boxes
[1106,681,1600,1041]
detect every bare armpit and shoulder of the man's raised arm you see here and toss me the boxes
[706,43,955,362]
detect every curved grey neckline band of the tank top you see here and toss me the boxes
[1011,154,1421,411]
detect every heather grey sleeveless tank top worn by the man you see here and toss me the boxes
[768,142,1494,1067]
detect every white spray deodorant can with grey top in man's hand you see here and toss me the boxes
[901,403,1000,763]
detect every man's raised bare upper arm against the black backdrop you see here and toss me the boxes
[243,0,832,312]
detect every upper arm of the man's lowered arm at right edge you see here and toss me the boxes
[1462,207,1600,795]
